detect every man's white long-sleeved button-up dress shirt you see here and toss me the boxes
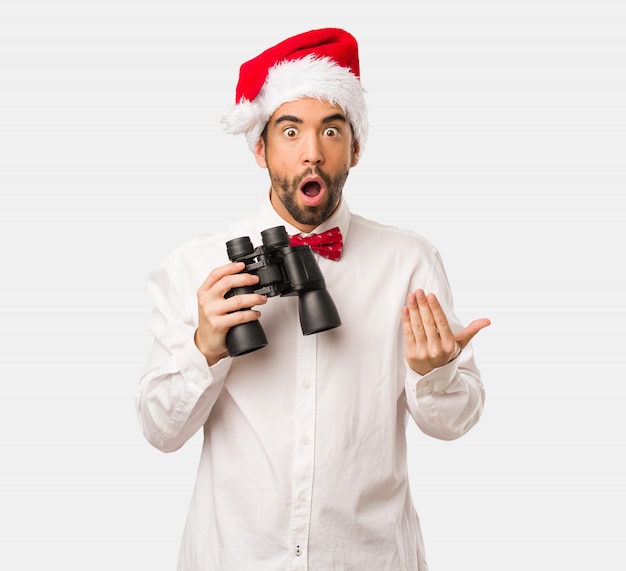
[136,199,484,571]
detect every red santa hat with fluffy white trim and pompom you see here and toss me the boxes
[223,28,368,150]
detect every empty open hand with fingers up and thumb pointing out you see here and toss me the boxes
[402,289,491,375]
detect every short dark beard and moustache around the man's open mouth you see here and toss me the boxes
[268,165,349,226]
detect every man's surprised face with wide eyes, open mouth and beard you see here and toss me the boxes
[255,99,359,232]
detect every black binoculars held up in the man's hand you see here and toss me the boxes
[226,226,341,357]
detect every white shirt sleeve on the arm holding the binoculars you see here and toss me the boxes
[135,252,232,452]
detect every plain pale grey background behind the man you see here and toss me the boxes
[0,0,626,571]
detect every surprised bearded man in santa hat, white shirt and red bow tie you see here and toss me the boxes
[137,28,489,571]
